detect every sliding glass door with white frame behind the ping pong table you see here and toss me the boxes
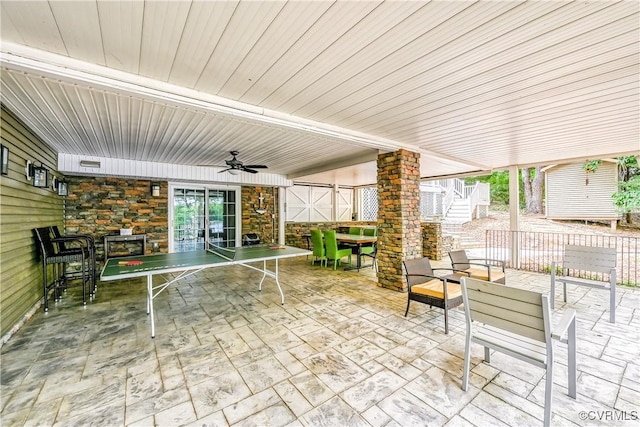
[169,185,240,252]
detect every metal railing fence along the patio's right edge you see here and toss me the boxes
[485,230,640,286]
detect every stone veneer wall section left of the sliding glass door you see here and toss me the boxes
[65,176,169,265]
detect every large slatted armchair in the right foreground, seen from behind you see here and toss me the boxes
[461,277,577,426]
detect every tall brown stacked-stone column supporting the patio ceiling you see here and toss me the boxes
[378,150,422,291]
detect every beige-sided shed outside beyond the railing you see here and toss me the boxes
[542,159,620,228]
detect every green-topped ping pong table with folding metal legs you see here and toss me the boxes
[100,245,312,338]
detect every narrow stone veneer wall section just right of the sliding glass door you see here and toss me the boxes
[241,186,279,243]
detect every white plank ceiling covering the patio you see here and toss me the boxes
[0,0,640,185]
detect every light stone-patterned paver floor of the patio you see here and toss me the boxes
[0,258,640,426]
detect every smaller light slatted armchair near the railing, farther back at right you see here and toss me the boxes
[551,245,617,323]
